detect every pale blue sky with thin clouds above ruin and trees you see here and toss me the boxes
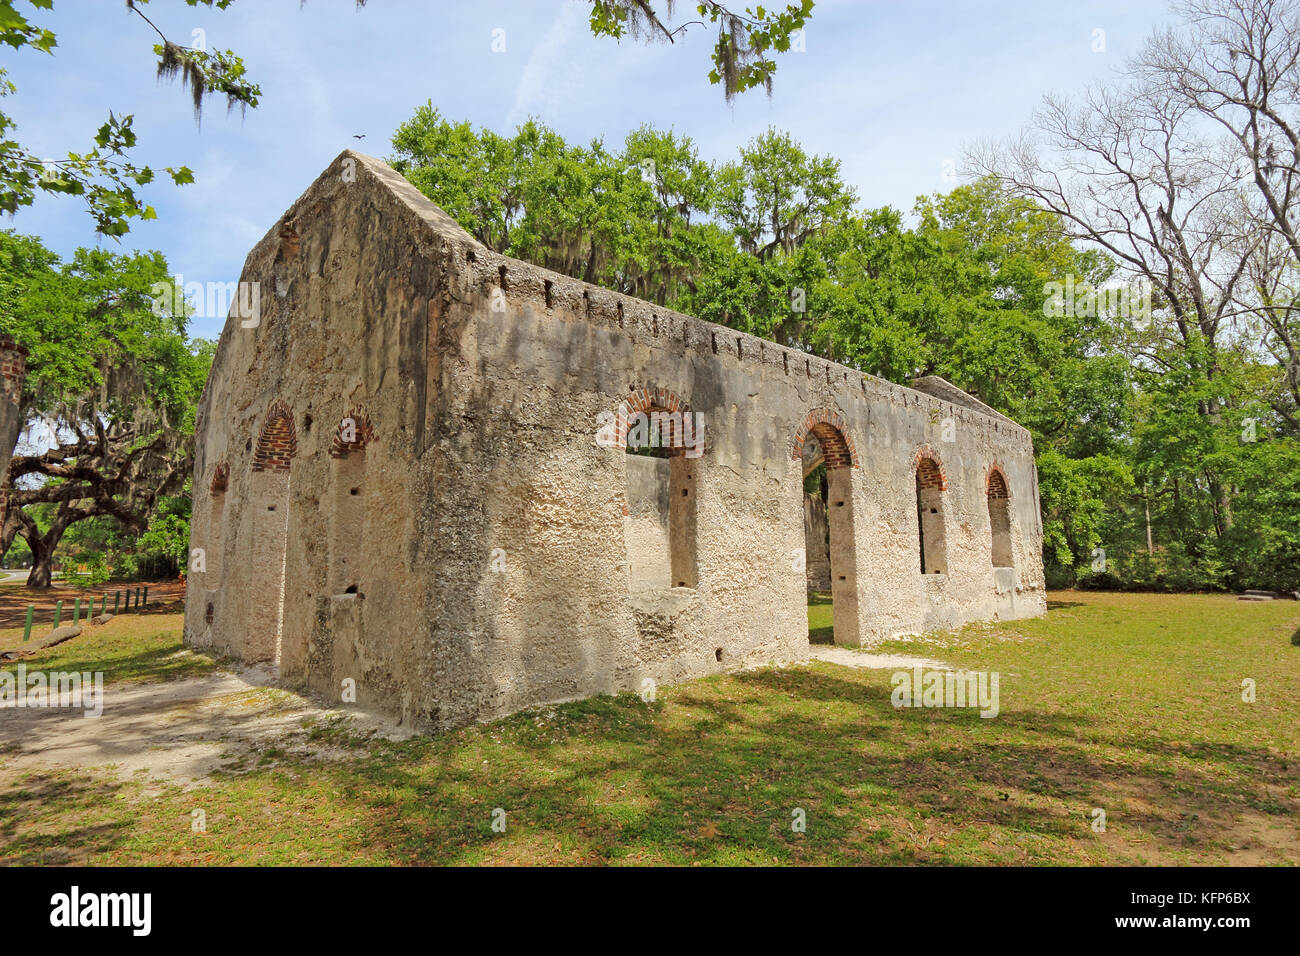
[0,0,1169,338]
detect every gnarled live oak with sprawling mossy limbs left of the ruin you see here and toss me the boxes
[0,232,212,588]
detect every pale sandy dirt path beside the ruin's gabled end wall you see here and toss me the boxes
[0,650,408,787]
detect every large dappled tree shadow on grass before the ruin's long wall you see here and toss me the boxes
[266,670,1296,864]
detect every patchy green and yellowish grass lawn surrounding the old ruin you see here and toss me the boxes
[0,592,1300,865]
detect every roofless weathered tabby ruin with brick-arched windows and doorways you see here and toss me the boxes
[185,151,1045,730]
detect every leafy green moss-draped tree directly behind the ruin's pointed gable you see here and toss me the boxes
[393,104,729,304]
